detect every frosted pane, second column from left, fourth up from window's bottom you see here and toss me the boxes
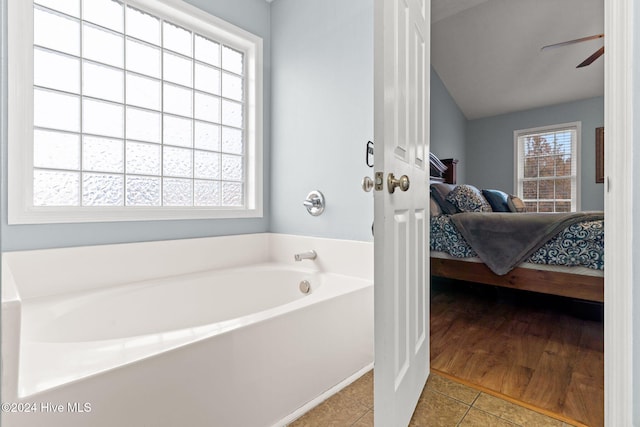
[82,61,124,102]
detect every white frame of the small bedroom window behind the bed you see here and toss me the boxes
[513,121,582,212]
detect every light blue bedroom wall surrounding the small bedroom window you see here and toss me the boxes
[465,97,604,210]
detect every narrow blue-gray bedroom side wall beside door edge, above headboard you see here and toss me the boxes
[431,67,467,184]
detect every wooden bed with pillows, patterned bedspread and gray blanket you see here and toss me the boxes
[430,156,604,302]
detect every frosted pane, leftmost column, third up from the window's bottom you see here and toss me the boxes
[33,89,80,132]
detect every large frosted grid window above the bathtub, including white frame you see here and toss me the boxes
[9,0,262,223]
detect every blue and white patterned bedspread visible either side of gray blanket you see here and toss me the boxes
[431,215,604,270]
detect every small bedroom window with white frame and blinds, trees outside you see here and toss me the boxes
[514,122,580,212]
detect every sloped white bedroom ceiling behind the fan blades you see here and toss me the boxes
[431,0,606,119]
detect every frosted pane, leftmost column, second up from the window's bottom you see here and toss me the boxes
[33,129,80,170]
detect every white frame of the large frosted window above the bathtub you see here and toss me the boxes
[7,0,264,224]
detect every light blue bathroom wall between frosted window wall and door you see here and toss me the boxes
[271,0,373,241]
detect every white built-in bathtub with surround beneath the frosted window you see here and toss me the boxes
[2,235,373,427]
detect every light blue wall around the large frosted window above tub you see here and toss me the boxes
[0,0,271,251]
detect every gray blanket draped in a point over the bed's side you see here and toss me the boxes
[451,212,604,276]
